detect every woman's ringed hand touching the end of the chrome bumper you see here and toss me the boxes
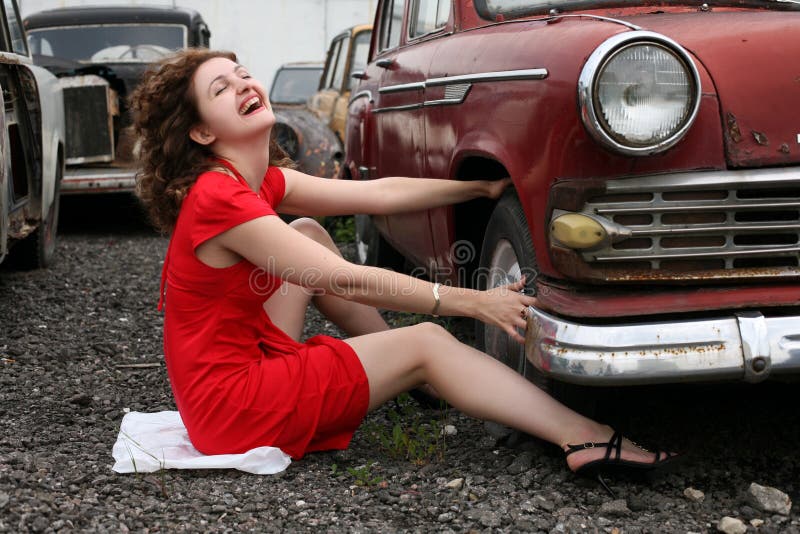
[476,276,538,344]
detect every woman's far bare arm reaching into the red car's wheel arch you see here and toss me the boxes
[278,169,511,216]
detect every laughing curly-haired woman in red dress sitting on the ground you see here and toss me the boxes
[132,50,674,486]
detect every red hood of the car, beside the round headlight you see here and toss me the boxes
[623,10,800,167]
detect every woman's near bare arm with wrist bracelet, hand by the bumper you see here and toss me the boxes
[213,216,536,342]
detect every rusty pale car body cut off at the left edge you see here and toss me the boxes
[0,0,65,268]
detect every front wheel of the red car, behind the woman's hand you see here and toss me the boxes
[475,192,594,434]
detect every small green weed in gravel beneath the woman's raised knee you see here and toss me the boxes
[364,393,449,465]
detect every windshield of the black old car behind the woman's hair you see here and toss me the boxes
[28,24,186,63]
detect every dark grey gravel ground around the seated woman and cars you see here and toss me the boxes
[0,198,800,532]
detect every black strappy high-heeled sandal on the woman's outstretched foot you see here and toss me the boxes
[565,431,679,498]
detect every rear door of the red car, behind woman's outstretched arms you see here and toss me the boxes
[372,0,435,268]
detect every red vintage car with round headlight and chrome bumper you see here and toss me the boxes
[344,0,800,402]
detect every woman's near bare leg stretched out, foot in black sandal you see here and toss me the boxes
[346,323,654,469]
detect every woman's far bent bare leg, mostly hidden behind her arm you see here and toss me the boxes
[264,217,389,340]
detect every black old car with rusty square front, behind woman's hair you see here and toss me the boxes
[24,6,210,194]
